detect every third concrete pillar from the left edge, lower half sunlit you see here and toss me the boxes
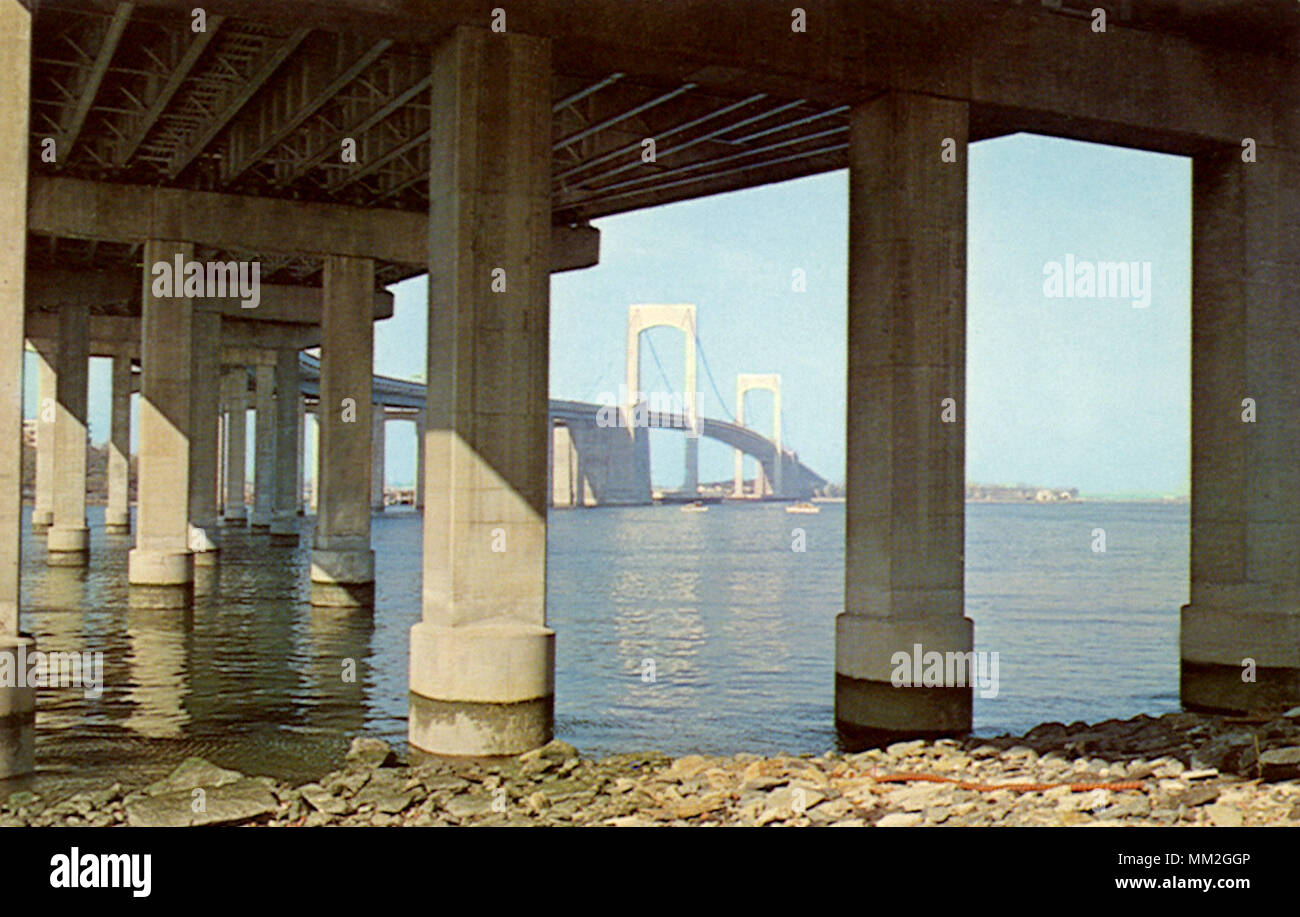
[46,303,90,567]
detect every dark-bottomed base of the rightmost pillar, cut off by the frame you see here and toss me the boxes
[1179,605,1300,714]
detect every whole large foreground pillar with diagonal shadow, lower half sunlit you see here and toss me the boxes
[408,27,555,754]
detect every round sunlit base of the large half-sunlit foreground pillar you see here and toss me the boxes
[408,618,555,756]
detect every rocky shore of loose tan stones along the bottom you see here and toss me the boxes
[0,708,1300,827]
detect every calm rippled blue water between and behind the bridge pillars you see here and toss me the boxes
[10,503,1188,791]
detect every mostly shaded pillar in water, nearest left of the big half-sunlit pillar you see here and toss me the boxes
[312,255,374,607]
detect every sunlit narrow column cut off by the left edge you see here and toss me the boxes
[0,0,36,778]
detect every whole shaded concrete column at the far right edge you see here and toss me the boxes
[1180,146,1300,713]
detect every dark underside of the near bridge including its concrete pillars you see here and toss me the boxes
[0,0,1300,775]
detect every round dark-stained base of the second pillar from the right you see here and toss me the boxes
[835,613,975,747]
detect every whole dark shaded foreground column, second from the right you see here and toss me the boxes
[835,92,974,743]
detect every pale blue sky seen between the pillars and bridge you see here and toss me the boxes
[26,134,1191,496]
